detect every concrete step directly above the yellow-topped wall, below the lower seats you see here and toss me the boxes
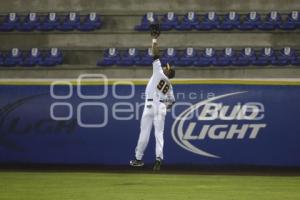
[0,65,300,79]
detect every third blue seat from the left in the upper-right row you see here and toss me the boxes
[176,11,200,31]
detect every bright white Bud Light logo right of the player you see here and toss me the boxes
[172,92,266,158]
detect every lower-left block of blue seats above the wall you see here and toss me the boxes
[0,48,63,67]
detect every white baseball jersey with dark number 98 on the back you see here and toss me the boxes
[146,59,175,101]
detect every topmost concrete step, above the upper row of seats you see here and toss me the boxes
[0,0,300,14]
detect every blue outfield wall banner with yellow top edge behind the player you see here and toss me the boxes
[0,77,300,166]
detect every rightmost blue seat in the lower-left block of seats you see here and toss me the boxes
[40,48,63,66]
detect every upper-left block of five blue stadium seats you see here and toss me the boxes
[0,12,102,31]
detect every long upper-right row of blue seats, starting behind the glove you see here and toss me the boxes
[135,11,300,31]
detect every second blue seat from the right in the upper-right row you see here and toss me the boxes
[258,11,281,30]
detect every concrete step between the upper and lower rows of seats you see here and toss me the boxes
[0,32,300,50]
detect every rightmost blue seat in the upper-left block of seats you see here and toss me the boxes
[77,12,101,31]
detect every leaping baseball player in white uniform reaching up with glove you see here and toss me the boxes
[130,25,175,171]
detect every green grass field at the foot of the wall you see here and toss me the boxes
[0,172,300,200]
